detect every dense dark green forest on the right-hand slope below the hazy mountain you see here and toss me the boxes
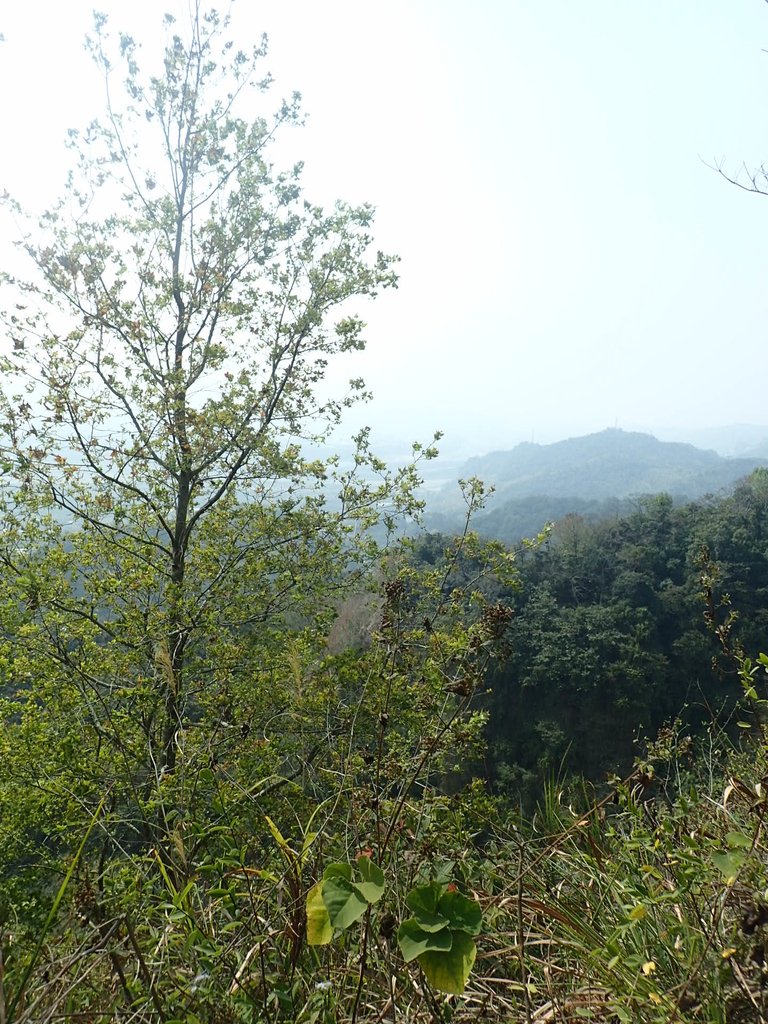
[486,471,768,810]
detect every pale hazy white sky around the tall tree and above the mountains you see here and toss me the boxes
[0,0,768,454]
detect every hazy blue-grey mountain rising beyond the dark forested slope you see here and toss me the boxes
[426,429,768,541]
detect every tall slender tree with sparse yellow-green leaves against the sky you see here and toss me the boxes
[0,3,421,864]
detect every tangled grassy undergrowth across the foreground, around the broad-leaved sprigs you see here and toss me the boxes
[0,708,768,1024]
